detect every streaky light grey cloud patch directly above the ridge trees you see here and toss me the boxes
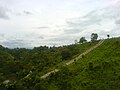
[64,14,101,34]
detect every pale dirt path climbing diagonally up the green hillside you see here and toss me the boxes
[40,39,104,79]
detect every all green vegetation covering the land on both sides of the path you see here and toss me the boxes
[0,38,120,90]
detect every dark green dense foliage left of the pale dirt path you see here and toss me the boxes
[0,41,98,90]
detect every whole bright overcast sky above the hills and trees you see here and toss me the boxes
[0,0,120,48]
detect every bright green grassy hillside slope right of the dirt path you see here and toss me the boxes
[35,38,120,90]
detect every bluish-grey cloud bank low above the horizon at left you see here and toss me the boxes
[0,33,44,48]
